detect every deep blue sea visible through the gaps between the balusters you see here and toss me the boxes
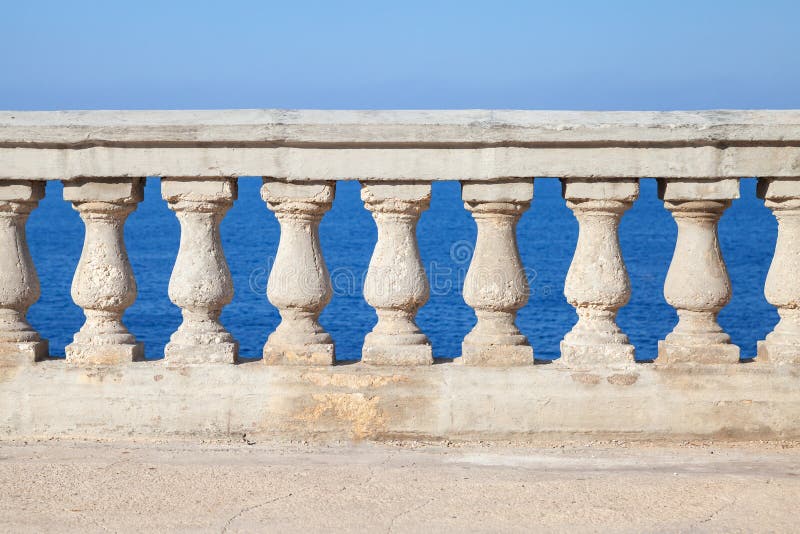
[28,178,778,360]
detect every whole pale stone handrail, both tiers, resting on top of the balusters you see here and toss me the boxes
[0,110,800,180]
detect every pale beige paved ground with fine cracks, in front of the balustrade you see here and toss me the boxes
[0,441,800,533]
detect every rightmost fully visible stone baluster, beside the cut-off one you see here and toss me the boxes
[658,179,739,363]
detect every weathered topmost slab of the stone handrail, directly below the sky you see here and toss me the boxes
[0,109,800,146]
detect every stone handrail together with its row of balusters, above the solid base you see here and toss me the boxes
[0,110,800,444]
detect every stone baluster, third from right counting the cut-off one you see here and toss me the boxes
[561,179,639,366]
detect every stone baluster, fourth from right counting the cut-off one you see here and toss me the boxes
[461,180,533,366]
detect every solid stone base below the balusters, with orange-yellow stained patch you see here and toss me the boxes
[0,360,800,441]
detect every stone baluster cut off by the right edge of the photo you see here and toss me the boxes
[758,178,800,363]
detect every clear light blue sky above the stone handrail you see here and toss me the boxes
[0,0,800,109]
